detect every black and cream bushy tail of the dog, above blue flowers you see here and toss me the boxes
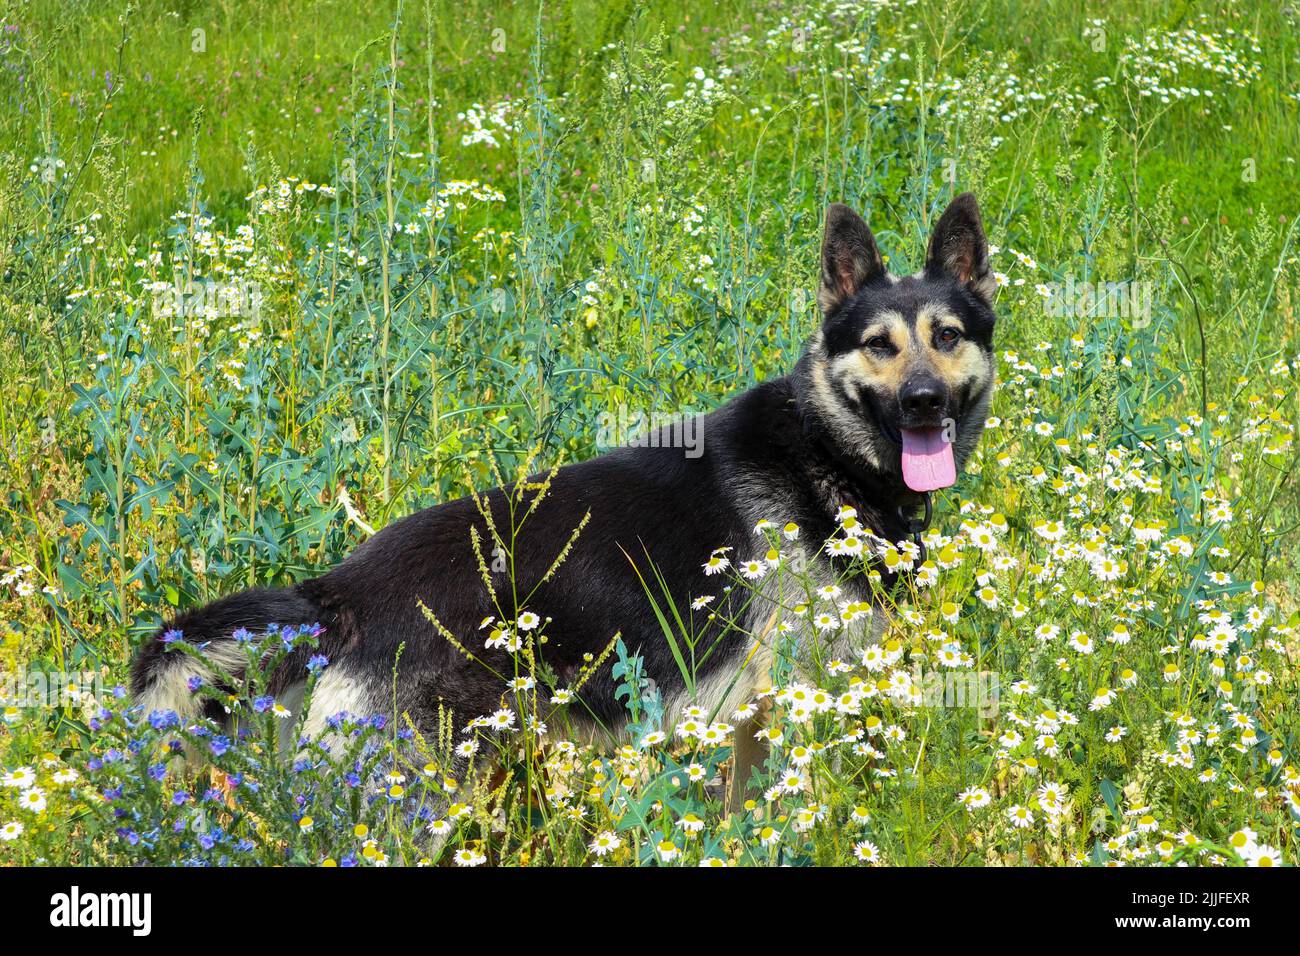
[131,588,321,719]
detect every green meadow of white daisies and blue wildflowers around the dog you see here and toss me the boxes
[0,0,1300,866]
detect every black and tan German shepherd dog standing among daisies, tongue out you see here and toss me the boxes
[131,194,995,796]
